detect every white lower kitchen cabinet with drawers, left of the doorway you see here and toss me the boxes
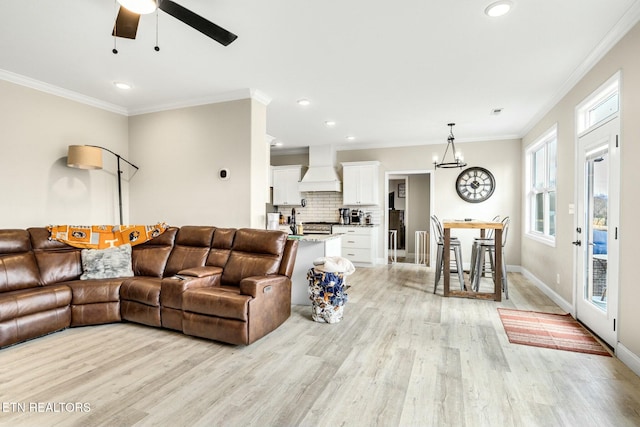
[332,225,379,265]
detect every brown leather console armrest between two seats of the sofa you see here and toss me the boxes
[160,267,222,309]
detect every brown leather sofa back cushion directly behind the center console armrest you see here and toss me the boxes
[164,225,215,277]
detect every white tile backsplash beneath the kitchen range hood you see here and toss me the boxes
[276,191,382,224]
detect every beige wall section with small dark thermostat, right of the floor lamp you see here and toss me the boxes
[129,99,268,228]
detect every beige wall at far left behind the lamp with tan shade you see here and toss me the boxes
[0,80,128,228]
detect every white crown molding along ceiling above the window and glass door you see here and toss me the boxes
[520,0,640,138]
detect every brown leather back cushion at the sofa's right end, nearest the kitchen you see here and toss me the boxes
[221,228,287,286]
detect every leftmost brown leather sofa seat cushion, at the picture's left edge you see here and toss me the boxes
[0,284,71,322]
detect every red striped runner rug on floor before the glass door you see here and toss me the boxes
[498,308,611,356]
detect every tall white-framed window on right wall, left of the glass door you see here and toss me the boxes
[526,125,558,246]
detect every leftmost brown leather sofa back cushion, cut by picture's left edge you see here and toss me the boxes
[0,230,40,292]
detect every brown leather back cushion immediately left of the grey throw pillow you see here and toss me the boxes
[27,227,82,285]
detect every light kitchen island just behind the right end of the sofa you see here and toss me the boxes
[289,234,342,305]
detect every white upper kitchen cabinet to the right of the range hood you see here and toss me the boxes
[342,162,380,205]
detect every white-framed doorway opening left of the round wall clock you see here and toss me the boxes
[384,170,433,266]
